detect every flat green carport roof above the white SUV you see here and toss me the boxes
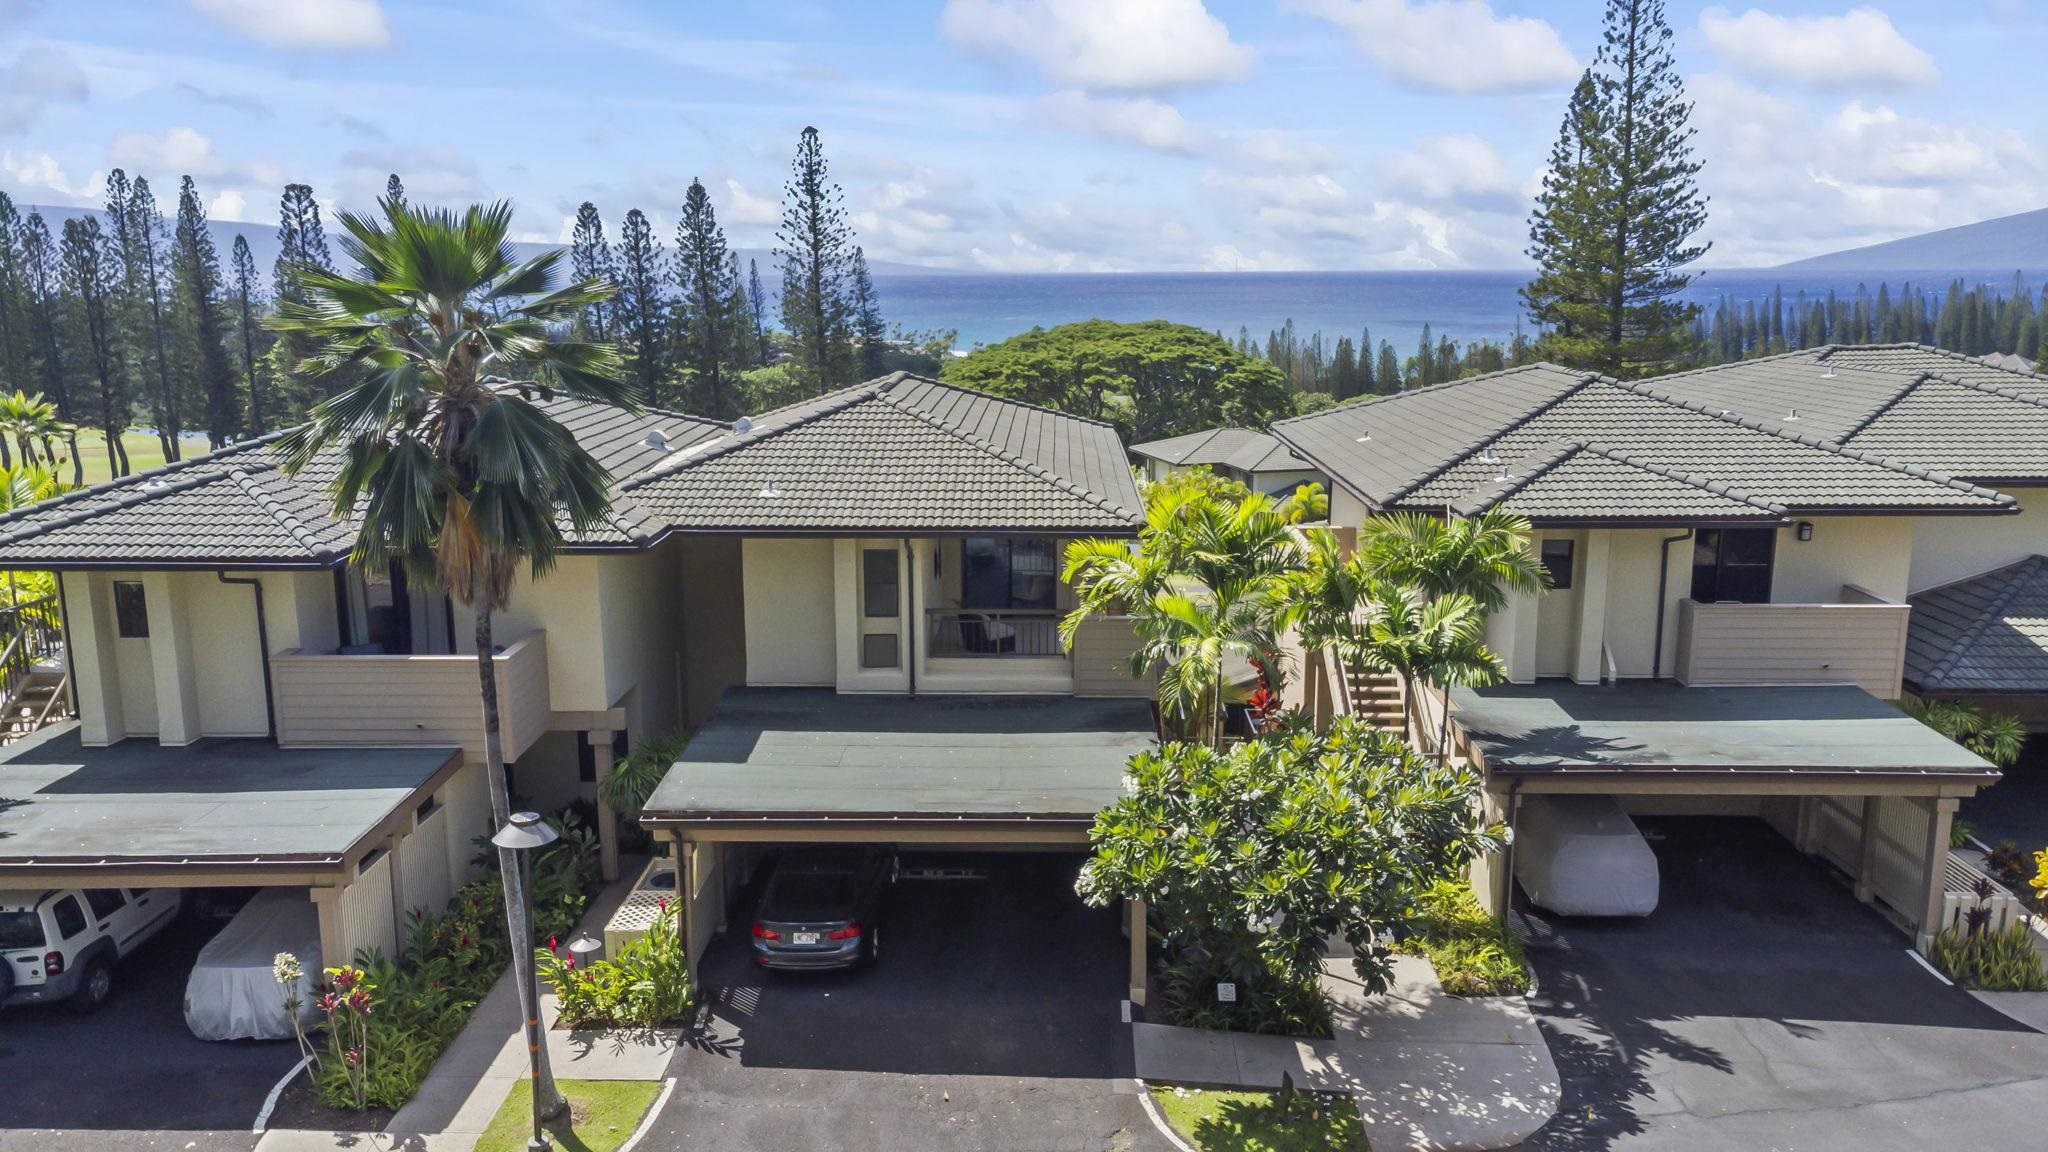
[0,724,461,865]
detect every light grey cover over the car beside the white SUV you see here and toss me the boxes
[184,888,319,1039]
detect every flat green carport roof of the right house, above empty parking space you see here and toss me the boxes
[1452,681,1999,791]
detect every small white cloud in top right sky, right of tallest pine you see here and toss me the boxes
[1700,4,1942,88]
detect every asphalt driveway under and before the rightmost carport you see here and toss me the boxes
[1524,818,2048,1152]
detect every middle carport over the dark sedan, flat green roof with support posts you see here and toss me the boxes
[641,689,1157,1002]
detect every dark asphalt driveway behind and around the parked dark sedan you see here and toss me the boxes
[647,853,1167,1152]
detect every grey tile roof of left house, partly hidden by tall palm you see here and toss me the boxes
[0,398,725,568]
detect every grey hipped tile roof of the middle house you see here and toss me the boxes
[623,373,1141,533]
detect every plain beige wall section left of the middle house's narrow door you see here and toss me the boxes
[739,537,838,687]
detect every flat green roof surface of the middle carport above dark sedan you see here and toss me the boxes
[641,689,1155,826]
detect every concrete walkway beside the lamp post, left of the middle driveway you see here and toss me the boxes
[256,859,678,1152]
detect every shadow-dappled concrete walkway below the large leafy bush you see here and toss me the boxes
[1133,955,1559,1150]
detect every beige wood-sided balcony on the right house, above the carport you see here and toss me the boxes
[1675,584,1913,699]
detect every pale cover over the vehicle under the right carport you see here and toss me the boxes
[1516,795,1657,916]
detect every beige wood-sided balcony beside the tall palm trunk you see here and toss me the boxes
[270,631,549,760]
